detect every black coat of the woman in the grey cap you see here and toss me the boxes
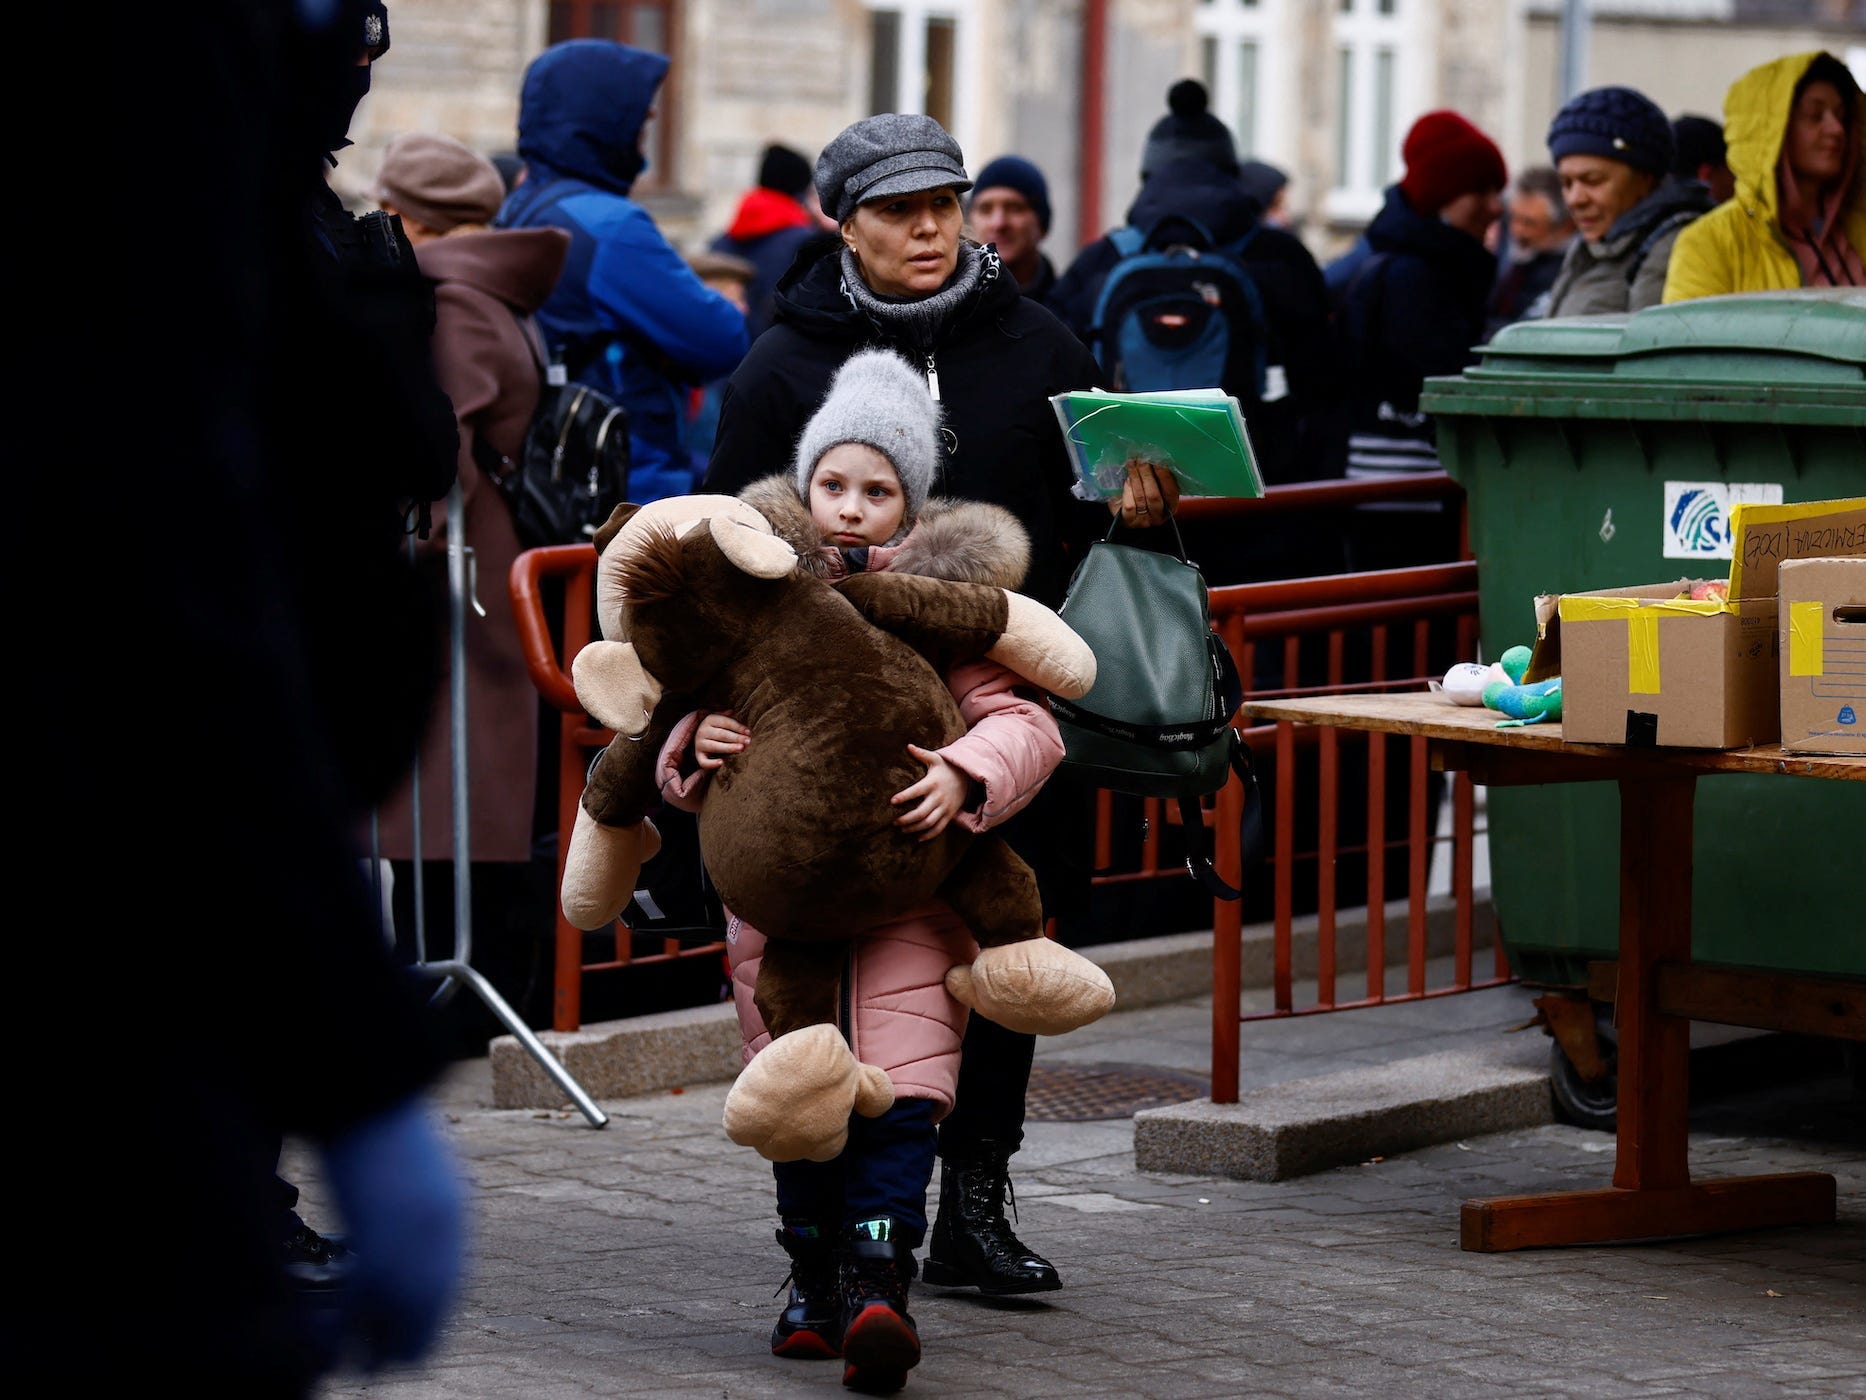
[702,243,1108,607]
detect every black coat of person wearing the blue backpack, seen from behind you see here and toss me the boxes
[1049,161,1342,482]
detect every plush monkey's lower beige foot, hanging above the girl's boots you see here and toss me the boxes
[724,1025,894,1161]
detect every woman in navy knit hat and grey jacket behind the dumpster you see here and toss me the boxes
[1549,88,1711,315]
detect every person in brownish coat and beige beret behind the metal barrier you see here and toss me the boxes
[365,133,569,1030]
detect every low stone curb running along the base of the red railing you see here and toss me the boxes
[487,898,1491,1109]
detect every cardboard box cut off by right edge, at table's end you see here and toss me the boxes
[1776,558,1866,756]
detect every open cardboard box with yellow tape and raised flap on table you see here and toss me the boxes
[1525,497,1866,749]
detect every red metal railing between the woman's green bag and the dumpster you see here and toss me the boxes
[1095,472,1510,1103]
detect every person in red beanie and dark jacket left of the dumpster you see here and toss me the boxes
[1327,110,1510,569]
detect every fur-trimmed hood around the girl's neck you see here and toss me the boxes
[739,472,1030,590]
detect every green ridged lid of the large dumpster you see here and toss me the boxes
[1422,287,1866,424]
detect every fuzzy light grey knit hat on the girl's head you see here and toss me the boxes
[793,351,939,526]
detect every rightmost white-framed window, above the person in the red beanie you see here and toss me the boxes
[1327,0,1420,220]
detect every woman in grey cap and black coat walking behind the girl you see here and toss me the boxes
[703,114,1177,1314]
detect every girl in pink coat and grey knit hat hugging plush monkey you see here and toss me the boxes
[657,351,1064,1393]
